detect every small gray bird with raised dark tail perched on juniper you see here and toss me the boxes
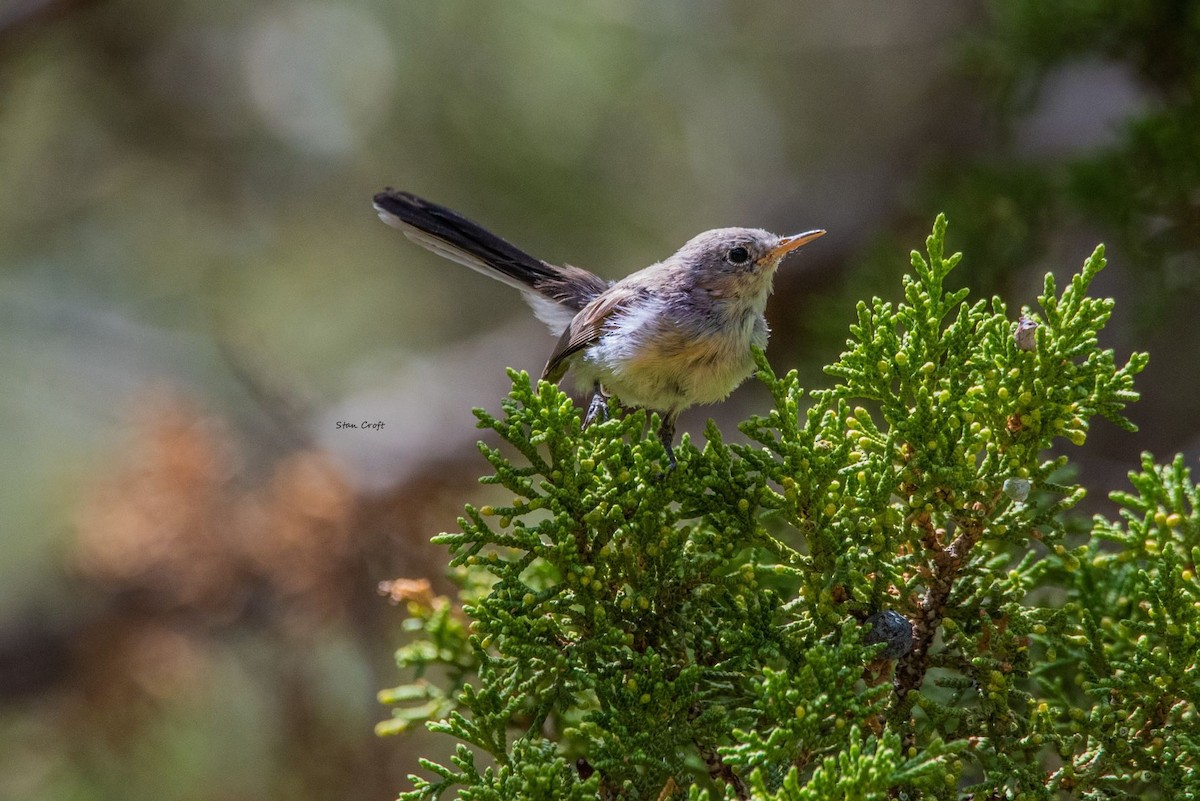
[374,188,824,468]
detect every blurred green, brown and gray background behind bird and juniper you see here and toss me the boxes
[0,0,1200,801]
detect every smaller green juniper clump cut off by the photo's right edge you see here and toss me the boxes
[1044,453,1200,799]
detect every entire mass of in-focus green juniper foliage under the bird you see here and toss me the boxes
[389,218,1200,801]
